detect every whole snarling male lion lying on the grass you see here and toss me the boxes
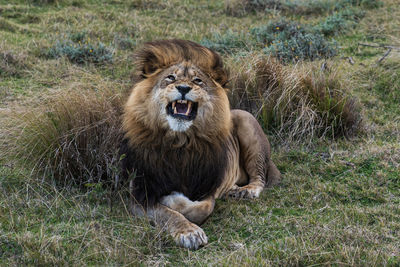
[120,40,280,250]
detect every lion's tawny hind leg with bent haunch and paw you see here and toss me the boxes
[228,110,280,198]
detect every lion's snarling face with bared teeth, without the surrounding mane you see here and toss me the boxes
[152,63,225,132]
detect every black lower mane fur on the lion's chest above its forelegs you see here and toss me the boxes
[120,139,227,207]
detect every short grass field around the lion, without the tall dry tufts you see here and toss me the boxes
[0,0,400,266]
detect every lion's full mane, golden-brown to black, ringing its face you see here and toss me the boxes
[120,40,232,207]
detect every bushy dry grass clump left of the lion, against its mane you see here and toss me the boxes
[0,77,123,186]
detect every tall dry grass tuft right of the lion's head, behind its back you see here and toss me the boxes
[230,55,362,142]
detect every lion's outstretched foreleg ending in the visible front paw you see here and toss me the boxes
[132,204,208,249]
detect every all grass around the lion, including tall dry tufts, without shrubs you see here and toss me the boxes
[0,0,400,266]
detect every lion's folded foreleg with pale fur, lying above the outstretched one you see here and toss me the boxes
[160,192,215,225]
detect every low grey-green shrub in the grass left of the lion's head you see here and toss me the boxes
[46,33,114,64]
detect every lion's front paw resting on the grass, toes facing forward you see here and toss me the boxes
[172,223,208,250]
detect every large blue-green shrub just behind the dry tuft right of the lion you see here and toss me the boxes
[251,19,337,62]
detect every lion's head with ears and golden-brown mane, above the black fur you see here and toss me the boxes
[123,41,231,146]
